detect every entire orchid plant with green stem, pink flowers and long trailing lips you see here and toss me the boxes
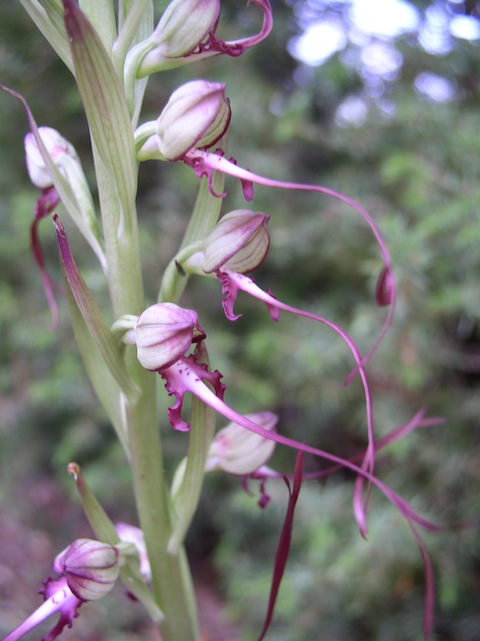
[0,0,474,641]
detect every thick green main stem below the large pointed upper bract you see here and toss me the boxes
[94,150,198,641]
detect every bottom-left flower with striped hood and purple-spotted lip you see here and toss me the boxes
[2,539,120,641]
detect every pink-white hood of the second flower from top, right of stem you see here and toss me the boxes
[156,80,231,160]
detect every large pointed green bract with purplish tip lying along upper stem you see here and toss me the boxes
[63,0,137,232]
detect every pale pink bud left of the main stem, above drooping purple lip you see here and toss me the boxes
[25,127,80,189]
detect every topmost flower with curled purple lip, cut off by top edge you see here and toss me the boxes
[134,0,272,78]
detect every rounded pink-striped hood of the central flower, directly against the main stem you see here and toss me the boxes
[134,303,205,372]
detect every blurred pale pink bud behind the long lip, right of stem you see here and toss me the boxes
[205,412,278,476]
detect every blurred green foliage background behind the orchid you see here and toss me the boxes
[0,0,480,641]
